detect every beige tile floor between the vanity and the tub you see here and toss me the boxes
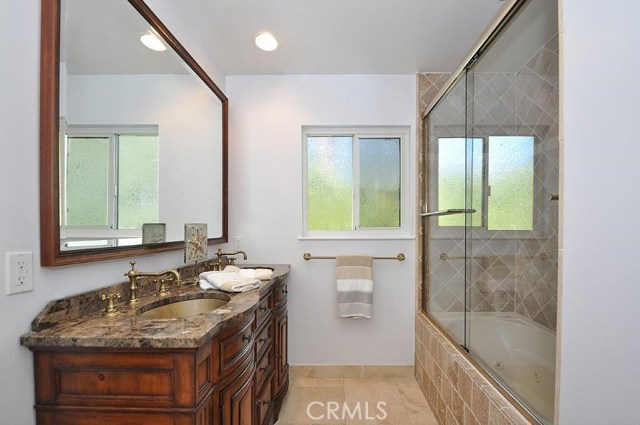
[276,377,438,425]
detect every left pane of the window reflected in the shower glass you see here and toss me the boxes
[438,137,482,226]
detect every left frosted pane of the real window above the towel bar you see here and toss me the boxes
[307,136,353,230]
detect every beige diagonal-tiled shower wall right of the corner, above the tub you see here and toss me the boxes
[515,35,560,330]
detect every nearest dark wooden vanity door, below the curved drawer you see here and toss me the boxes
[218,357,254,425]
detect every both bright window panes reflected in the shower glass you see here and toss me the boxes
[437,136,534,231]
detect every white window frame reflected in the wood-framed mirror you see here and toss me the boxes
[60,125,160,239]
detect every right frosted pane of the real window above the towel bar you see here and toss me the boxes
[360,138,400,227]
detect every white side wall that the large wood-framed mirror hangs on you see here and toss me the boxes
[0,0,224,425]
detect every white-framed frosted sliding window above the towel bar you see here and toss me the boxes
[303,127,408,238]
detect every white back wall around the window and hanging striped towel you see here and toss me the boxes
[226,75,415,364]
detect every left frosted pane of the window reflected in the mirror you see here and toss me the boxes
[65,137,109,227]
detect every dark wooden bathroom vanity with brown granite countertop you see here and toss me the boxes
[21,265,289,425]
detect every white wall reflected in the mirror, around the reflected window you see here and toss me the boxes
[65,74,222,241]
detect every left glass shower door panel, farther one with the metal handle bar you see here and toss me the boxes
[422,75,481,346]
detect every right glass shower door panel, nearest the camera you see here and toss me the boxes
[465,1,559,423]
